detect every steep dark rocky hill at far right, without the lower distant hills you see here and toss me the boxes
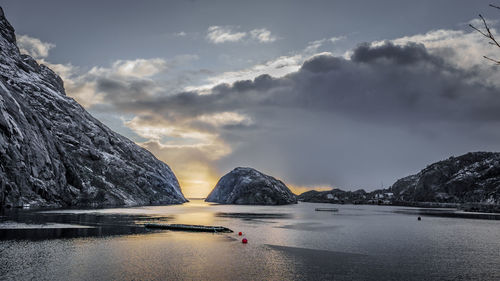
[390,152,500,204]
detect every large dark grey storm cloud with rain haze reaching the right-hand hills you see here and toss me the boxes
[85,43,500,189]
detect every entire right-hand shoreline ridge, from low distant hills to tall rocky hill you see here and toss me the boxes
[298,151,500,212]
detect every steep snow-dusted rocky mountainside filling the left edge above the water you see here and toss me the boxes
[0,9,186,207]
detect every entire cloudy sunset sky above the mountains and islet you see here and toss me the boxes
[0,0,500,197]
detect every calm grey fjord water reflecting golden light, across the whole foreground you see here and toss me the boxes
[0,200,500,280]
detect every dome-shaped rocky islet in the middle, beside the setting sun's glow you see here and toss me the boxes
[205,168,297,205]
